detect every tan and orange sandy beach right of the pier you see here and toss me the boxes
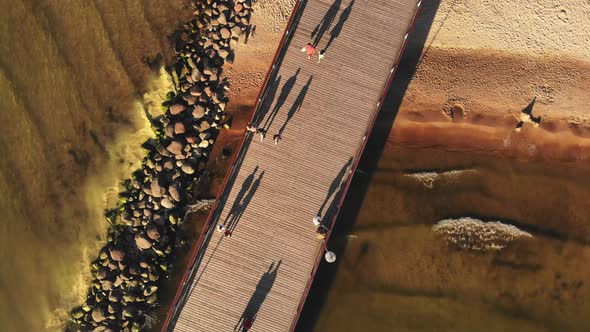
[395,0,590,160]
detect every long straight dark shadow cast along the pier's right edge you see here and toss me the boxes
[295,0,440,332]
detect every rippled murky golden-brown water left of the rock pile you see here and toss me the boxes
[0,0,192,331]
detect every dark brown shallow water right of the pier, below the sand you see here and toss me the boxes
[300,141,590,331]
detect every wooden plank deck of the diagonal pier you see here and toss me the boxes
[164,0,419,332]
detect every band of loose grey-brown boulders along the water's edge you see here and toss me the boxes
[69,0,252,331]
